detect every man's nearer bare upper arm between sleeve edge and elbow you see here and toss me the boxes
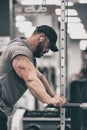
[12,55,37,81]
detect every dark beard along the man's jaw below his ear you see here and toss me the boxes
[33,42,43,58]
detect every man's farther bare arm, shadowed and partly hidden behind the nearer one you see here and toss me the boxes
[37,70,55,97]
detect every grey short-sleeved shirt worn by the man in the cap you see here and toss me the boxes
[0,36,35,115]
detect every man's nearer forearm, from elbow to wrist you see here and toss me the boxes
[26,78,52,103]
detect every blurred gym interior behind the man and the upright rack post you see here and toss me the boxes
[0,0,87,130]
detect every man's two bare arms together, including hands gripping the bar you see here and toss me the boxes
[12,55,66,106]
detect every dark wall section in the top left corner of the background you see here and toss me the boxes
[0,0,10,36]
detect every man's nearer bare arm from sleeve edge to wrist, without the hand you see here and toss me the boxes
[13,55,51,103]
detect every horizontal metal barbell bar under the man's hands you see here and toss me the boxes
[46,103,87,109]
